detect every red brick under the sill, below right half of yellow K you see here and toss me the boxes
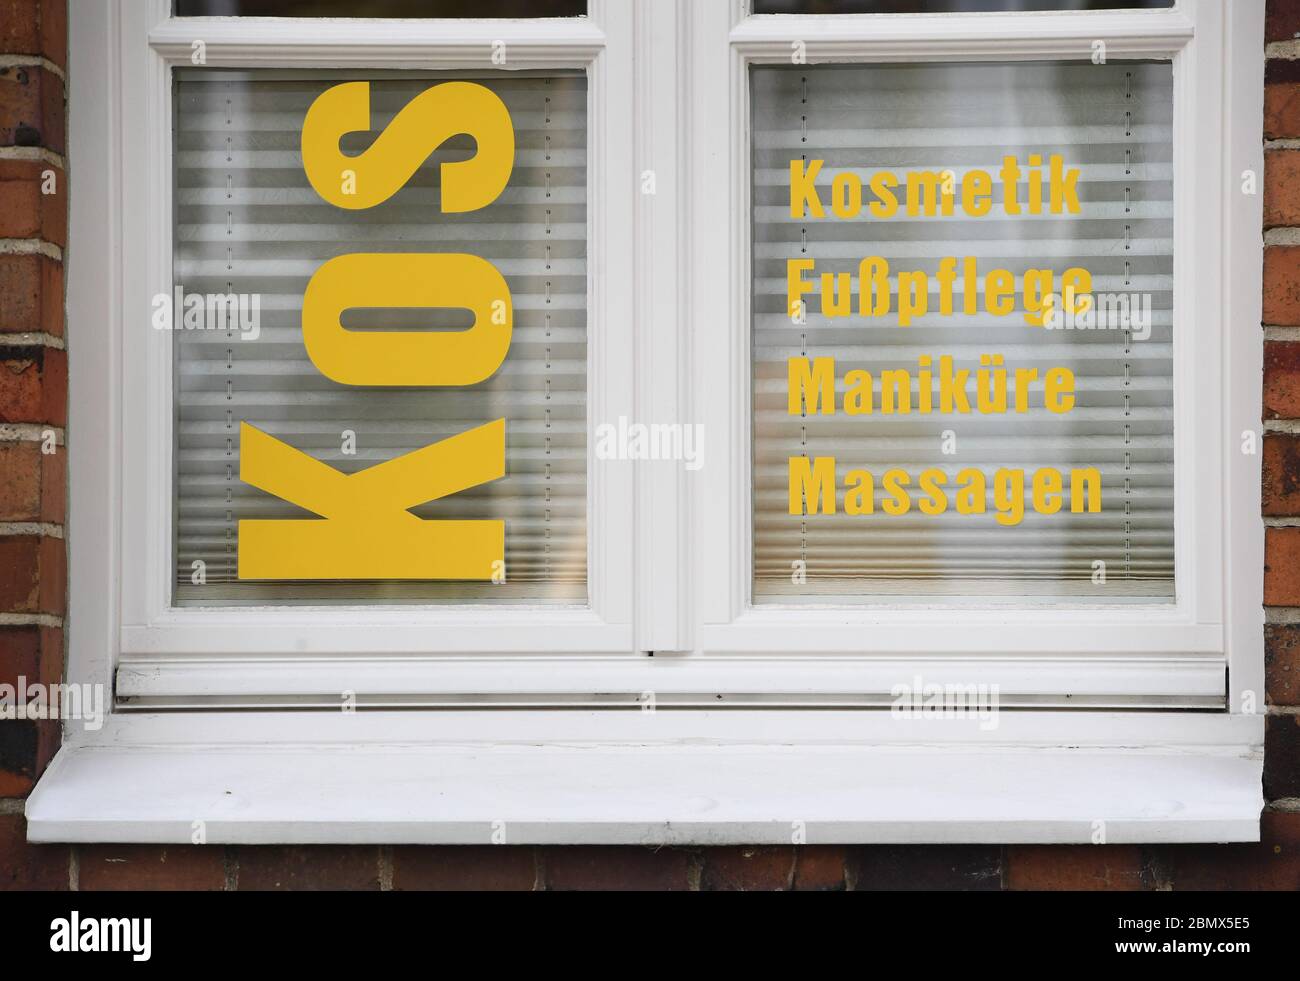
[393,845,537,893]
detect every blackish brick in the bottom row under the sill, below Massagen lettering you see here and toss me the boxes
[849,845,1002,891]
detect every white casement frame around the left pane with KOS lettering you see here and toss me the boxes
[97,0,634,690]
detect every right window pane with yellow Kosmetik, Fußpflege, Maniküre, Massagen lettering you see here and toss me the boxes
[751,62,1174,602]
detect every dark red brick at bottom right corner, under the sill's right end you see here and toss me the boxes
[1144,811,1300,893]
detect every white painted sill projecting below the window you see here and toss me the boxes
[26,711,1264,845]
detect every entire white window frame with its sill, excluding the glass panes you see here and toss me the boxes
[27,0,1264,843]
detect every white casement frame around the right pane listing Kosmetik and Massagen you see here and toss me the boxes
[694,0,1262,703]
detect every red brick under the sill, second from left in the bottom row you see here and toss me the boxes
[77,845,226,891]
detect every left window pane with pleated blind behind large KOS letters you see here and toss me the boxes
[173,70,588,604]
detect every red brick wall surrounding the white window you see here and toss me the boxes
[0,0,1300,890]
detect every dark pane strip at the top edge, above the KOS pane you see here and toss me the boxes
[176,0,586,17]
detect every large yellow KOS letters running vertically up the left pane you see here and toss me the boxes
[239,82,515,581]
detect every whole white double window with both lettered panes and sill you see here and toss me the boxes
[29,0,1262,843]
